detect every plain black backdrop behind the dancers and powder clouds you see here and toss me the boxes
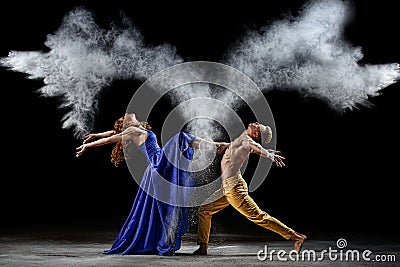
[0,0,400,242]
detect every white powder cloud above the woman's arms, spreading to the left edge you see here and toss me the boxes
[0,8,182,137]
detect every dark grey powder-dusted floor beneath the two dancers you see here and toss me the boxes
[0,226,400,267]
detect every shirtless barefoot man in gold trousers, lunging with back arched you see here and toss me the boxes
[193,122,307,255]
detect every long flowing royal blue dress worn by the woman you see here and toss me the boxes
[104,130,195,256]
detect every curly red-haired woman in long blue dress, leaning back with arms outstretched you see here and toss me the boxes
[76,113,227,256]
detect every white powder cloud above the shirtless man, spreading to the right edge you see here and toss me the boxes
[225,0,400,111]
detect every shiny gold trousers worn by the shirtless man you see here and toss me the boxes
[197,174,294,244]
